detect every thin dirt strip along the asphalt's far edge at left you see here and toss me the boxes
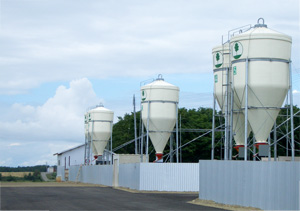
[0,182,107,187]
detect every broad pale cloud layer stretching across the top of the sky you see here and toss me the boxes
[0,0,299,95]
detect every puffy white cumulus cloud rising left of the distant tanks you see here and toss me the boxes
[0,78,100,141]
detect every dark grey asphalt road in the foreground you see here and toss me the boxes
[0,187,225,210]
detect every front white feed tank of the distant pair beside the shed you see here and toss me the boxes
[88,105,114,159]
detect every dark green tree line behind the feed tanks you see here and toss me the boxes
[113,105,300,162]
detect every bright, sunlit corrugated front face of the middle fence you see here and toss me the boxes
[140,163,199,191]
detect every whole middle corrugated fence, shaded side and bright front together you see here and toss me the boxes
[119,163,199,191]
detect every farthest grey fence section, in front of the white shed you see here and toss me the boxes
[69,165,113,186]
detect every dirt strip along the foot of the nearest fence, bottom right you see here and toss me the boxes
[188,199,261,211]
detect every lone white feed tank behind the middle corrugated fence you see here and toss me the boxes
[141,76,179,162]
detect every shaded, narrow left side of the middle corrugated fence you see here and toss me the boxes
[119,163,140,190]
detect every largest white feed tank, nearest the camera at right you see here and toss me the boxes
[230,19,292,145]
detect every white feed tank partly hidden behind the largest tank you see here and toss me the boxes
[212,43,251,150]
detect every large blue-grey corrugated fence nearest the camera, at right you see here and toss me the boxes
[199,161,300,210]
